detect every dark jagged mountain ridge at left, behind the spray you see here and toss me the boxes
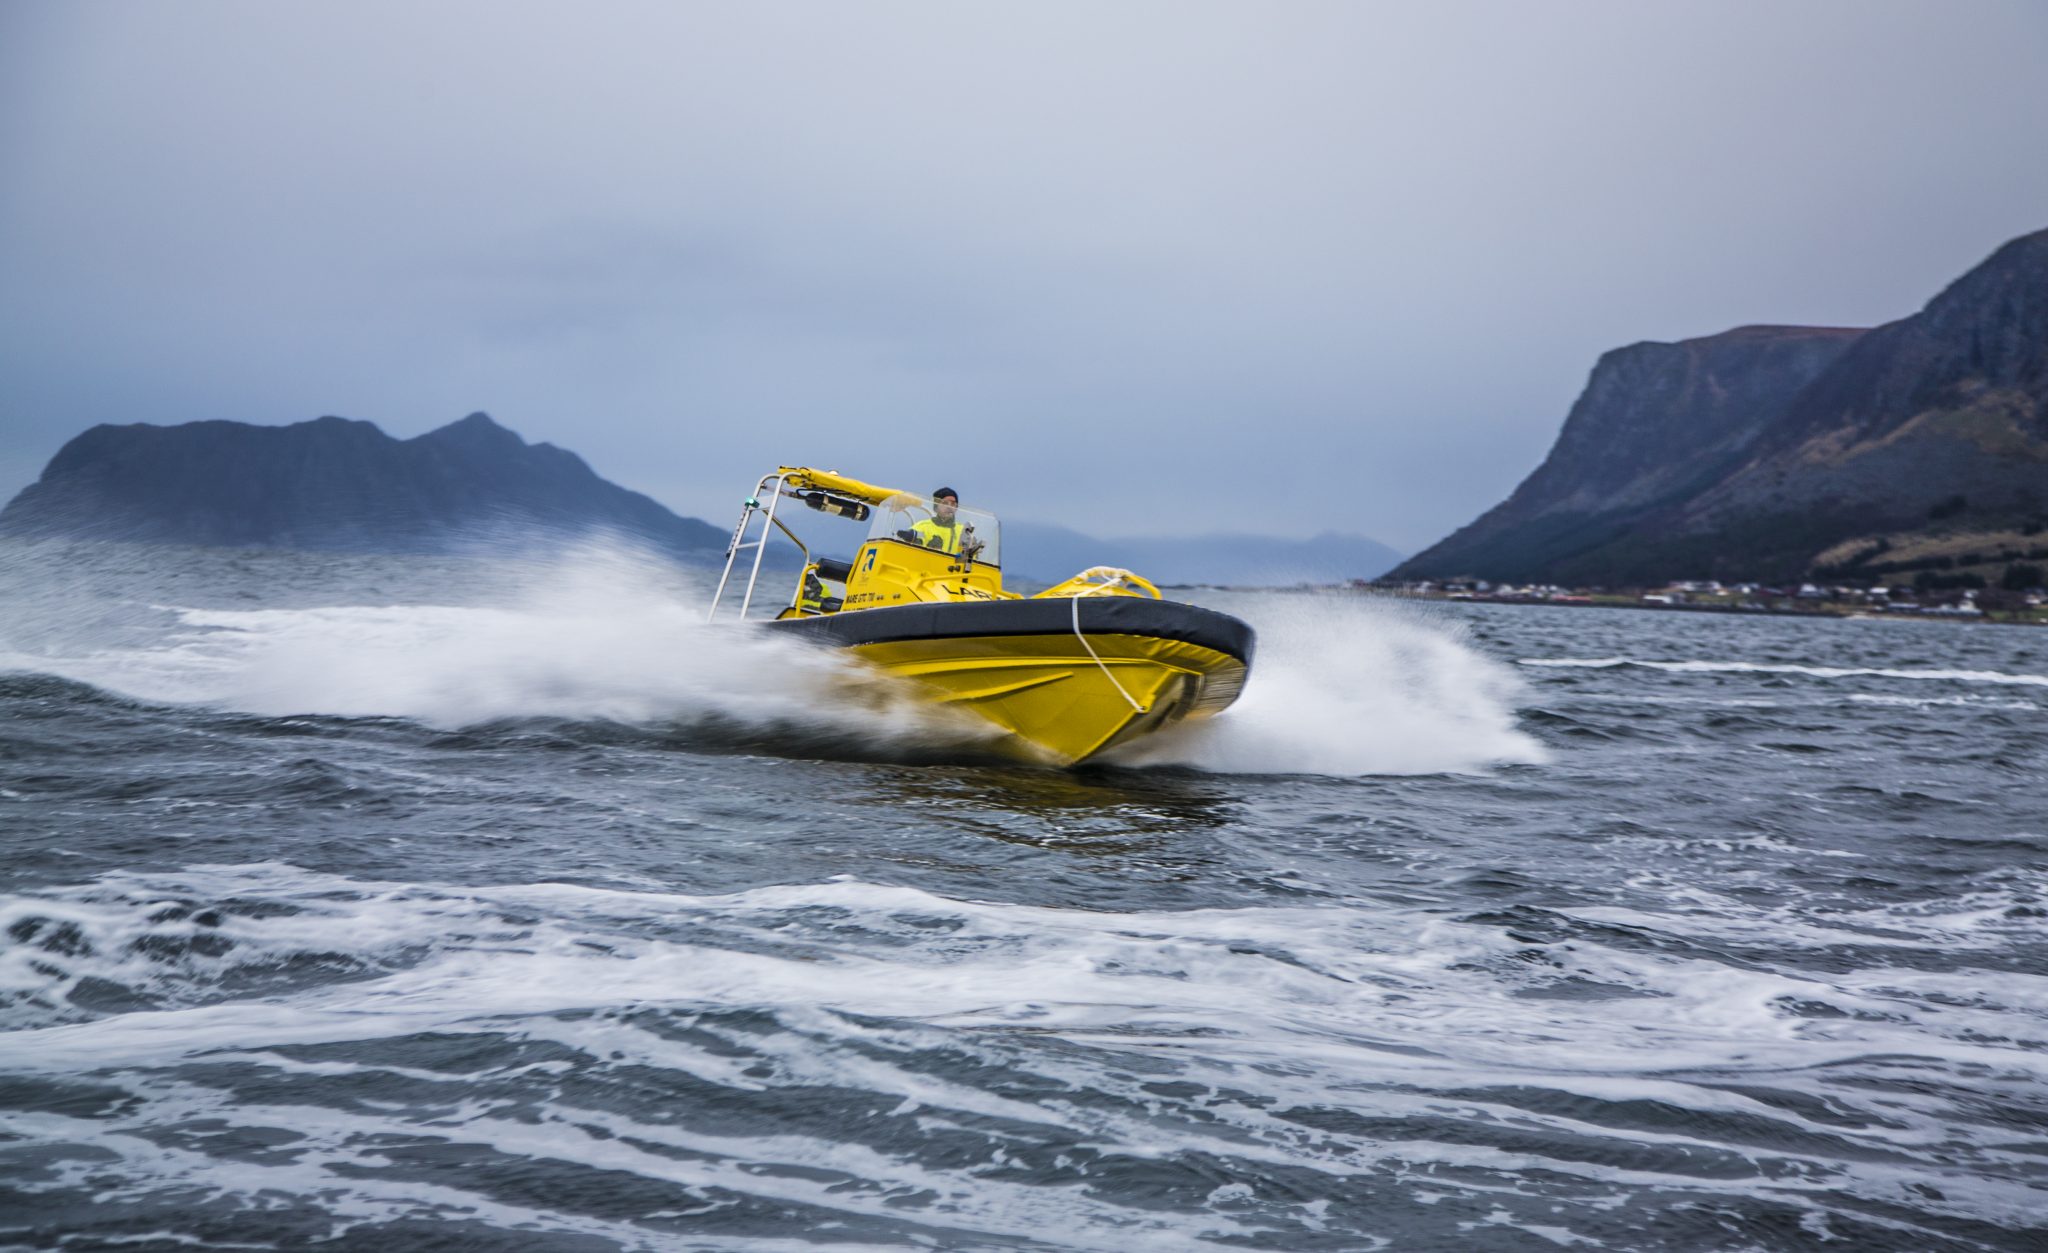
[0,414,725,555]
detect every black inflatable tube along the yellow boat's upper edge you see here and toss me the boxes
[774,596,1257,665]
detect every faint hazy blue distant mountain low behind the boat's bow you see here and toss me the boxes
[1004,522,1401,588]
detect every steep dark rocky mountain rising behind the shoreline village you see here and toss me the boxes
[1393,231,2048,586]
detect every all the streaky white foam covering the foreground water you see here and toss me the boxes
[0,864,2048,1247]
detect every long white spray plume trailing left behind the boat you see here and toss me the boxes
[0,543,987,751]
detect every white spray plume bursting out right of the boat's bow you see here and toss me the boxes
[1116,596,1544,776]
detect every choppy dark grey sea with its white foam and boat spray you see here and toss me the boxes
[0,543,2048,1251]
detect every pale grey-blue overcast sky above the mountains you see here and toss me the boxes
[0,0,2048,551]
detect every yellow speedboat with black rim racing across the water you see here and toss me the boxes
[711,465,1253,764]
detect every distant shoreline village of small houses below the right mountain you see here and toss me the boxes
[1352,567,2048,624]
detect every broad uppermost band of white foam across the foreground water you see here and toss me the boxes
[12,866,2048,1073]
